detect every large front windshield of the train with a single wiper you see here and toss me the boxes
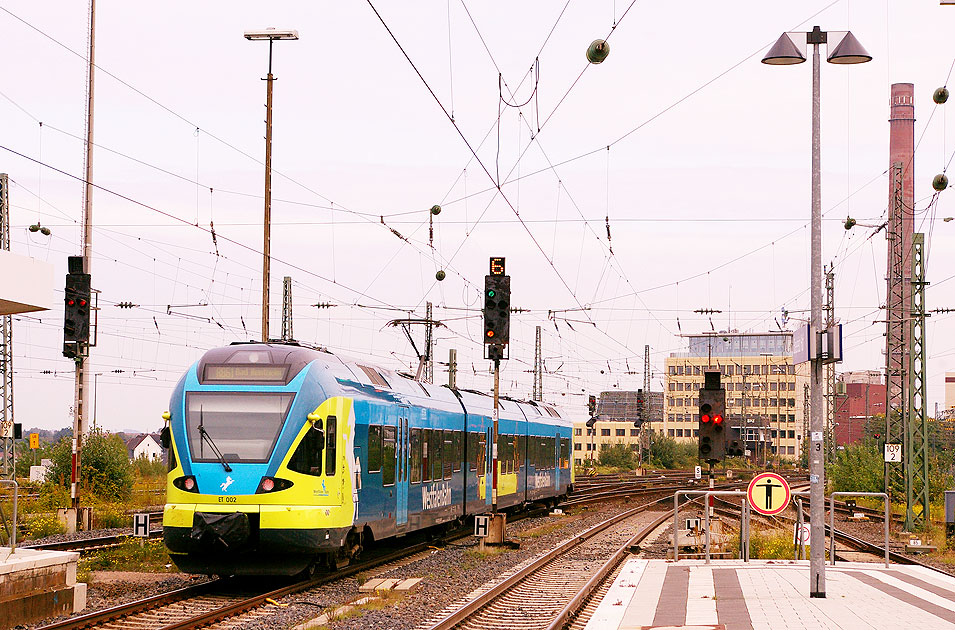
[186,392,294,463]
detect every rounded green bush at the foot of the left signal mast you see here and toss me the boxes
[47,428,133,499]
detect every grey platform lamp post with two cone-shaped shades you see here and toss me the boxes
[762,26,872,597]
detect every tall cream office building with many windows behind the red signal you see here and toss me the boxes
[655,331,809,464]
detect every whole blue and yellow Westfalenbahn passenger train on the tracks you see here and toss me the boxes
[162,343,573,575]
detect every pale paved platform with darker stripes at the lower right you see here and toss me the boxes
[586,559,955,630]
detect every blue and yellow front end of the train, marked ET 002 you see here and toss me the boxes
[163,346,358,575]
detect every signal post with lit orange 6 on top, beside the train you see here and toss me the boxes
[484,256,511,543]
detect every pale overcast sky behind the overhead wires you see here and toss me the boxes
[0,0,955,430]
